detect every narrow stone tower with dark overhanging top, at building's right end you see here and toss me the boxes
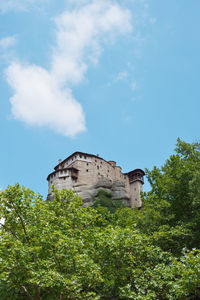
[127,169,145,208]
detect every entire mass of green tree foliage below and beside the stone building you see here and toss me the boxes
[0,140,200,300]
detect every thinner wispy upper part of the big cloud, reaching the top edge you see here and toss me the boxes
[52,1,131,83]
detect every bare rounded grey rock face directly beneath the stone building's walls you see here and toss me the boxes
[74,178,130,206]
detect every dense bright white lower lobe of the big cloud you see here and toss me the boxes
[6,63,85,136]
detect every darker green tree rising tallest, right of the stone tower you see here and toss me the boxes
[122,139,200,255]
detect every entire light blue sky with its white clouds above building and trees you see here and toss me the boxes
[0,0,200,196]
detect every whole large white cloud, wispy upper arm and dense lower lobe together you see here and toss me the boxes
[5,1,132,136]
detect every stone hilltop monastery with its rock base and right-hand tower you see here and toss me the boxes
[47,152,145,208]
